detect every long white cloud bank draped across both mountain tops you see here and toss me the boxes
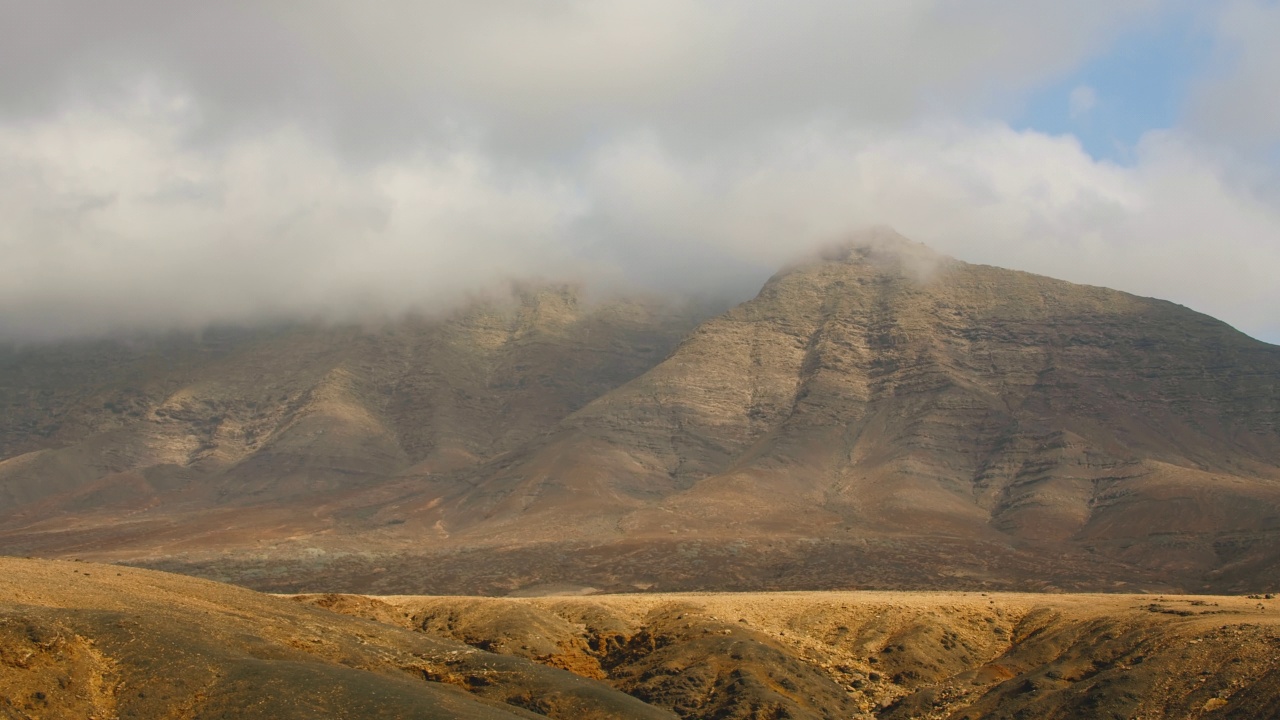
[0,87,1280,338]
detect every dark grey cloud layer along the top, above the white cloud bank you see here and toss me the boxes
[0,0,1158,155]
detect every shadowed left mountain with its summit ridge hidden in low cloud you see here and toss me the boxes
[0,286,707,553]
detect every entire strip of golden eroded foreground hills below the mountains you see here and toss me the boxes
[0,559,1280,720]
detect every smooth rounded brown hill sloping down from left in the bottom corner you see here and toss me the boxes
[0,559,672,720]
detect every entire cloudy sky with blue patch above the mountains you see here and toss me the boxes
[0,0,1280,342]
